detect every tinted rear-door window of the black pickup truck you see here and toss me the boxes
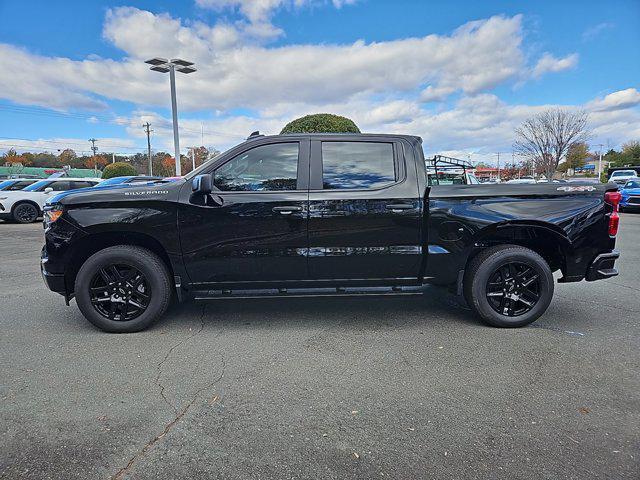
[322,142,397,190]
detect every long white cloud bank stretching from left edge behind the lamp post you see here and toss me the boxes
[0,11,525,110]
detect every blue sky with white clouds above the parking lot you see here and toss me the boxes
[0,0,640,159]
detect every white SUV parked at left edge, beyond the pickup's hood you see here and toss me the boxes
[0,178,100,223]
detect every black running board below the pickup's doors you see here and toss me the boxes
[193,286,424,300]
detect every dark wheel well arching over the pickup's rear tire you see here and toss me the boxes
[467,225,568,273]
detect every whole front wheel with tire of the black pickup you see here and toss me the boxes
[75,245,172,333]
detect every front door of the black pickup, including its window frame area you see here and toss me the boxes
[178,141,309,284]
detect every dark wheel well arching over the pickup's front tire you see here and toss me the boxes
[65,232,173,288]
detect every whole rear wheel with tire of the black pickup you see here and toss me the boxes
[464,245,554,327]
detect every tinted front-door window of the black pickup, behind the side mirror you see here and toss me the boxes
[213,142,299,192]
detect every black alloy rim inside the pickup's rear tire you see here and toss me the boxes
[486,262,540,317]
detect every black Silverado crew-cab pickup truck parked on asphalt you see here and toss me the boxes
[41,134,620,332]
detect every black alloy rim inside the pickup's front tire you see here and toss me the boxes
[89,264,151,322]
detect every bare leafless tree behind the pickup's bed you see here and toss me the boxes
[514,108,589,181]
